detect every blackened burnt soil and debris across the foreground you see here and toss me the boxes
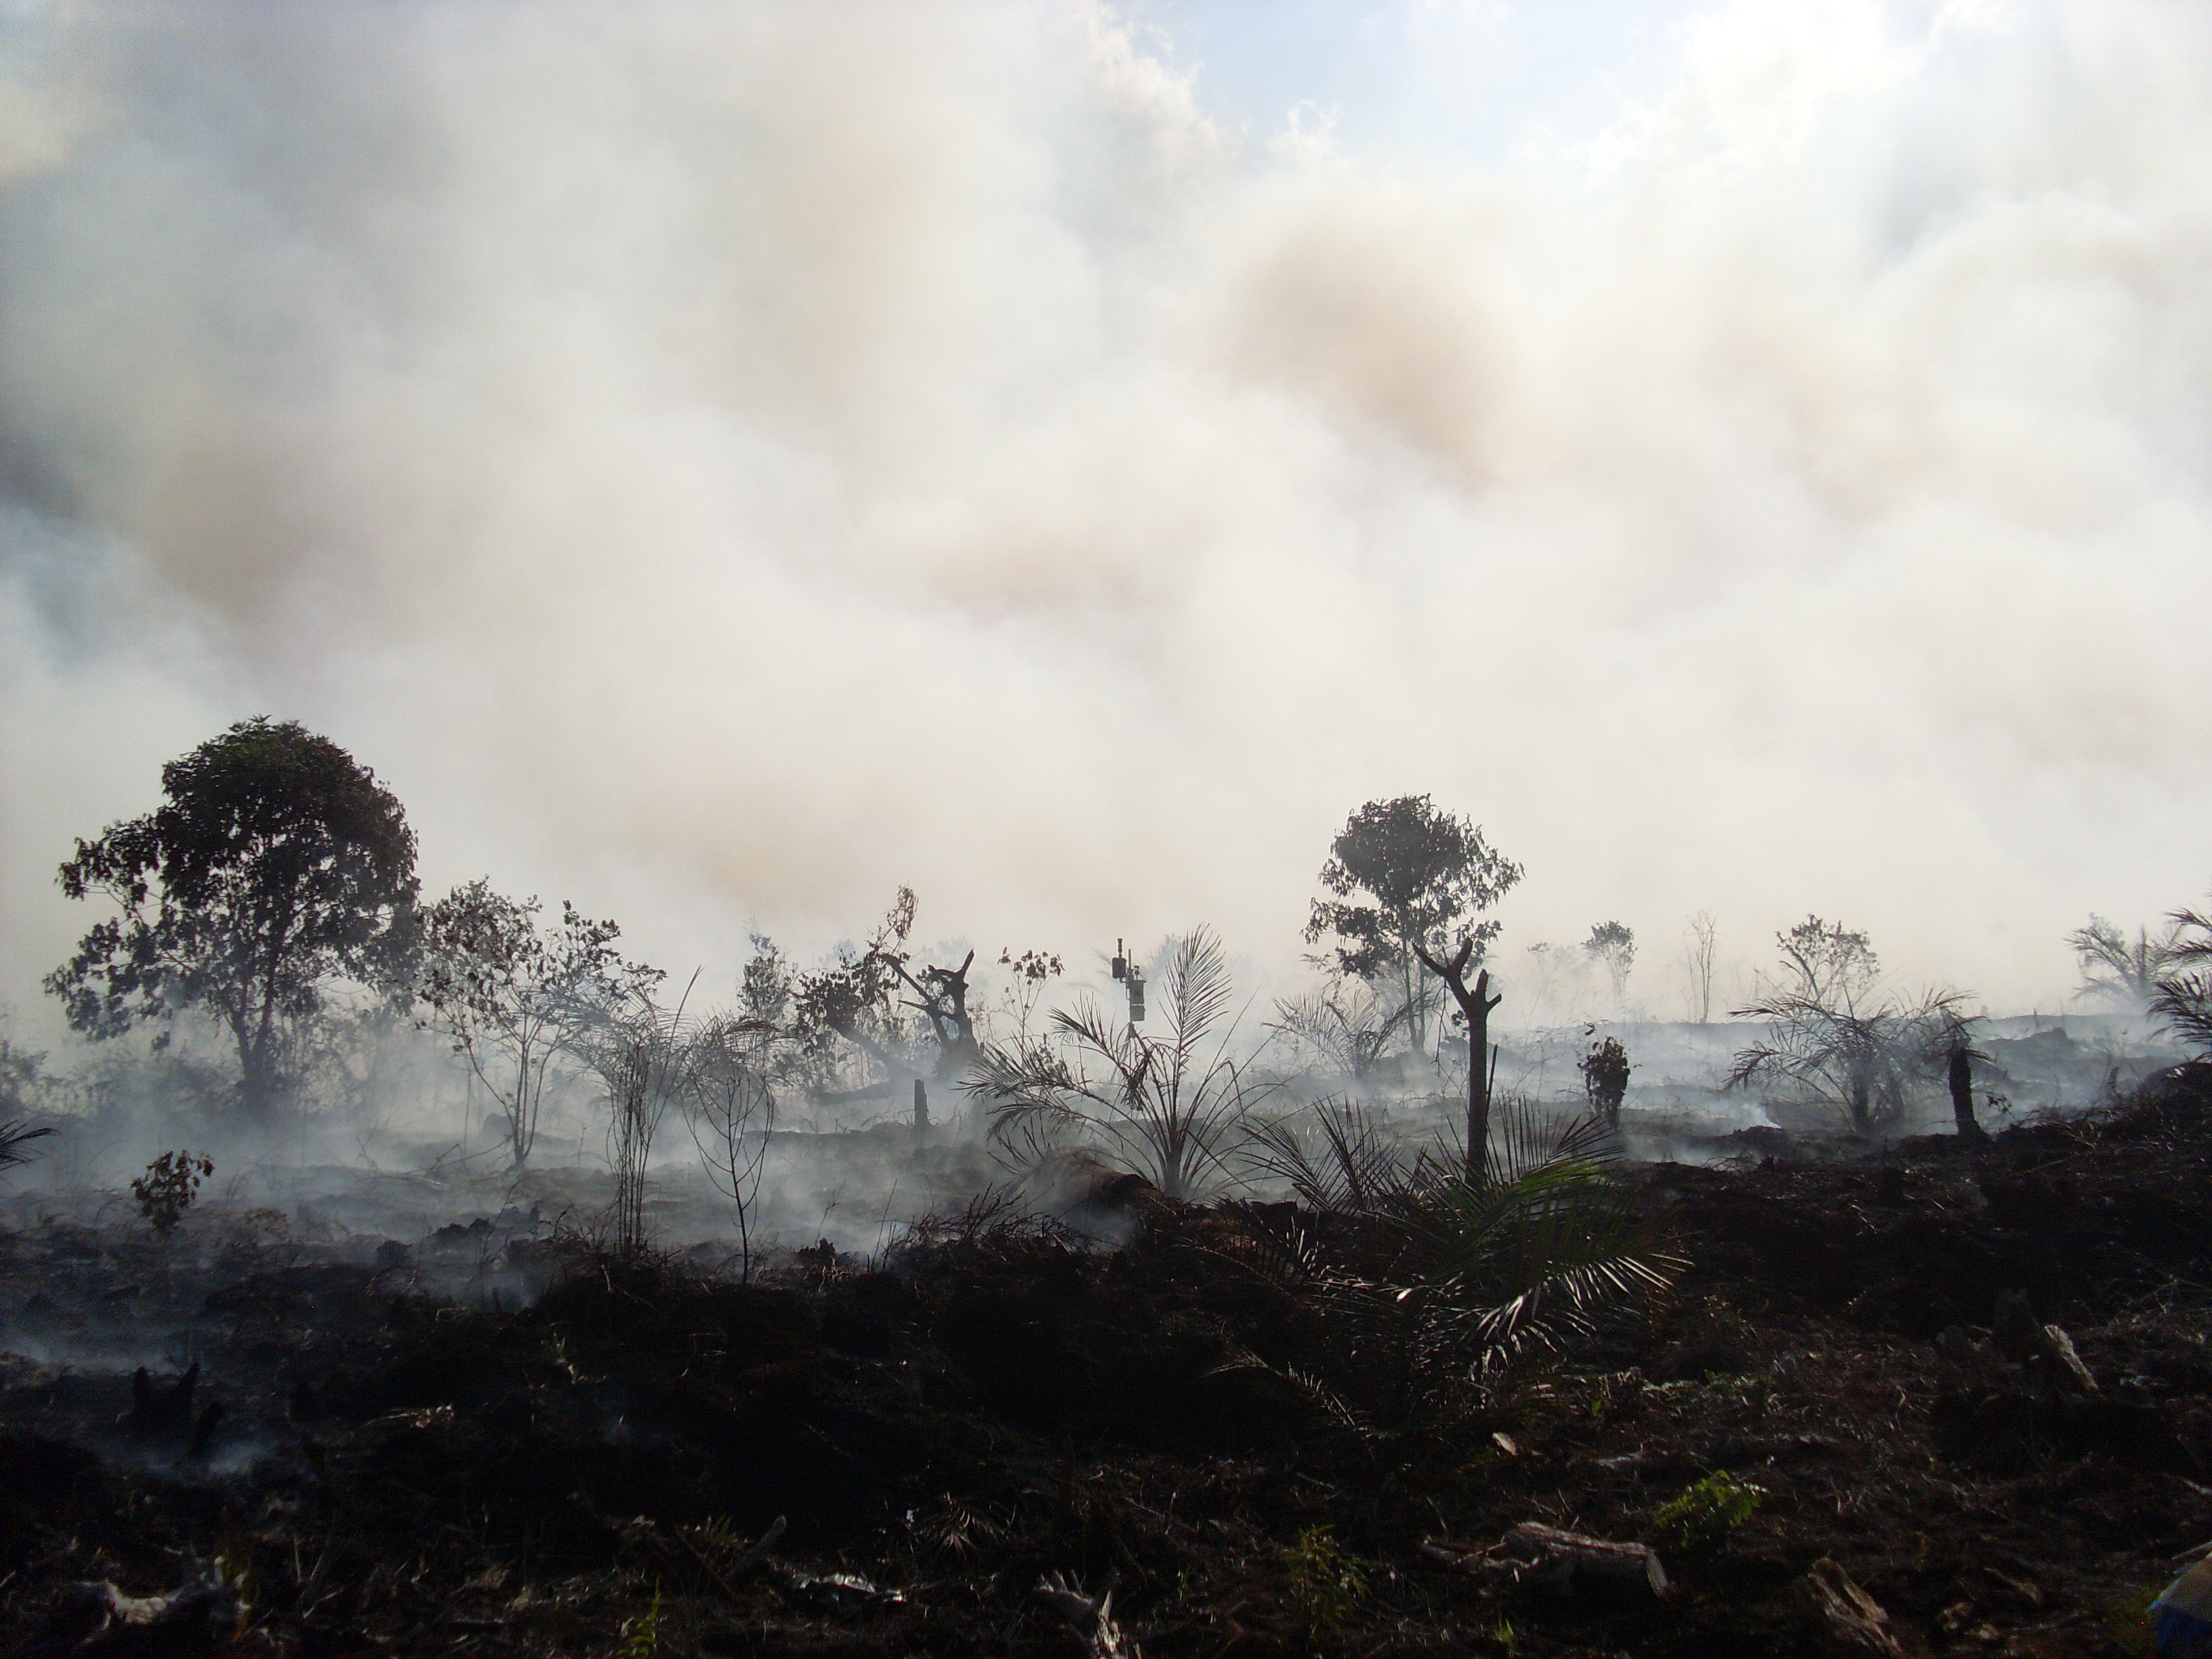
[0,1069,2212,1659]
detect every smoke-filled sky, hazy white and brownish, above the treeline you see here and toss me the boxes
[0,0,2212,1040]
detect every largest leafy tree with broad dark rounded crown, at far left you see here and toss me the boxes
[47,719,416,1117]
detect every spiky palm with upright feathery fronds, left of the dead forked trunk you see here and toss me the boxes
[962,927,1265,1199]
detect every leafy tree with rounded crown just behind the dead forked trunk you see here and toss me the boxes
[1305,794,1522,1048]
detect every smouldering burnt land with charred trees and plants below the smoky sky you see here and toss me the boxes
[0,743,2212,1659]
